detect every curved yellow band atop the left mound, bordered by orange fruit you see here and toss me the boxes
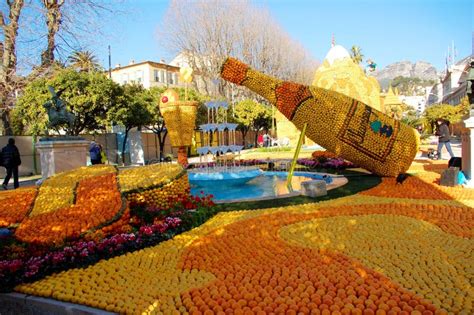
[30,165,116,217]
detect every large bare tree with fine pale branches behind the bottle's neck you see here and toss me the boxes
[158,0,316,98]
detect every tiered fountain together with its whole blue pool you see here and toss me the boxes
[188,101,343,203]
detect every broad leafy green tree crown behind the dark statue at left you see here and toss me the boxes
[14,68,122,135]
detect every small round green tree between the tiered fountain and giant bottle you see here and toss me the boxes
[234,99,272,146]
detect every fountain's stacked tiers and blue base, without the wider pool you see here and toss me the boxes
[188,101,263,186]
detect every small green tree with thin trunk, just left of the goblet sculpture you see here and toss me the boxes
[107,84,154,162]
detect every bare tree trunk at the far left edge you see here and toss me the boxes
[0,0,24,135]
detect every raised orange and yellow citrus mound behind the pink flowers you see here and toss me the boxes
[0,164,189,245]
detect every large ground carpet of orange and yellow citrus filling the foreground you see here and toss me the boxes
[15,161,474,315]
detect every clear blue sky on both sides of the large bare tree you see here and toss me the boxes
[93,0,474,70]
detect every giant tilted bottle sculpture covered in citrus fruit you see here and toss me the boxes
[221,58,420,176]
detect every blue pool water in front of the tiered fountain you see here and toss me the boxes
[189,172,332,202]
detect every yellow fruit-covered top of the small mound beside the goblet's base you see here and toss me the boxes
[119,163,183,193]
